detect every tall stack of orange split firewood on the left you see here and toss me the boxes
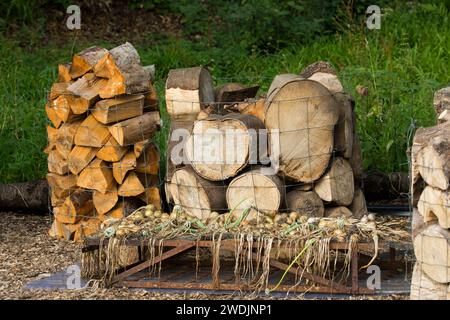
[45,43,160,240]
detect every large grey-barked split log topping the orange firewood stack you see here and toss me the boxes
[94,42,152,99]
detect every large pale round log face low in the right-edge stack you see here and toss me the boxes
[413,224,450,283]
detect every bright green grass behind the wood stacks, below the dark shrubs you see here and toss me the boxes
[0,4,450,182]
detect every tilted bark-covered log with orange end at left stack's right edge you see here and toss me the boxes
[109,111,161,146]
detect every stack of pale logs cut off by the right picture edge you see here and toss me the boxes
[411,88,450,300]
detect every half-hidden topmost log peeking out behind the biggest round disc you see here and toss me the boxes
[300,61,344,93]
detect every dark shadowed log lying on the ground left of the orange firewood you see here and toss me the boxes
[0,180,49,213]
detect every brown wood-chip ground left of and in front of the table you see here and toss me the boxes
[0,213,406,300]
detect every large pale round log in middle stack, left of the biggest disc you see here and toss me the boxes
[185,114,267,181]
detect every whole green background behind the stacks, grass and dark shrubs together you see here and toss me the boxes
[0,0,450,182]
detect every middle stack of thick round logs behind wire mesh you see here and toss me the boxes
[165,62,367,221]
